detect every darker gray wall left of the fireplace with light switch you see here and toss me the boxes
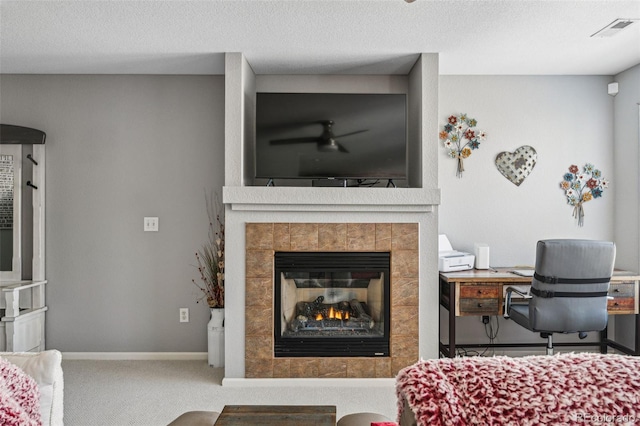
[0,75,224,352]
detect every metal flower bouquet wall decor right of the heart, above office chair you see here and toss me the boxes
[560,163,609,226]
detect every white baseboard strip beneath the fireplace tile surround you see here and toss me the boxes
[222,377,396,388]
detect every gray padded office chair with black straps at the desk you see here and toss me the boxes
[504,240,616,355]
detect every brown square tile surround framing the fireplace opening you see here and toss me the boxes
[245,223,419,378]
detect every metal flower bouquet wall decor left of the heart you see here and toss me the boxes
[440,114,487,178]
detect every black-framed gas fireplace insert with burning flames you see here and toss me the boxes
[274,252,390,357]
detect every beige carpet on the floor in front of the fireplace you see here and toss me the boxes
[62,360,396,426]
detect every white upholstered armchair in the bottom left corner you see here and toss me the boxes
[0,350,64,426]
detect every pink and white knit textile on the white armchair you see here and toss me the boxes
[0,357,42,426]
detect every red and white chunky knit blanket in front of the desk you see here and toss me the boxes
[396,353,640,426]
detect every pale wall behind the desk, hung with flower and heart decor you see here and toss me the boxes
[438,76,616,350]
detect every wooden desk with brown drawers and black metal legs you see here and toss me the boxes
[439,268,640,357]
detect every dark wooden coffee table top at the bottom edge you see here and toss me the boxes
[215,405,336,426]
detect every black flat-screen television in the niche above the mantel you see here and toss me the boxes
[255,93,407,179]
